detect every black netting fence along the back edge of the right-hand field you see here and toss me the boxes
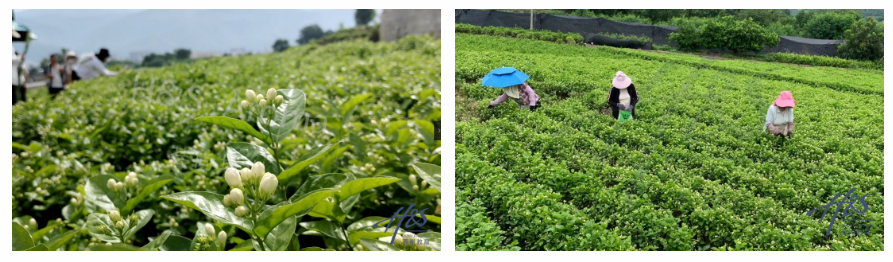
[456,9,843,56]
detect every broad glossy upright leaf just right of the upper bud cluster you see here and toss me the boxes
[257,89,307,143]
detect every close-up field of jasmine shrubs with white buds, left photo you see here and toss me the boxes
[12,37,441,251]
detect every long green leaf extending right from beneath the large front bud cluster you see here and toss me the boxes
[254,189,337,236]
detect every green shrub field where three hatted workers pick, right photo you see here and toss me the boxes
[455,33,884,250]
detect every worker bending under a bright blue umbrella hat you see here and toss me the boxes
[482,67,539,111]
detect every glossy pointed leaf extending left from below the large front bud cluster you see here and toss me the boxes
[161,191,254,232]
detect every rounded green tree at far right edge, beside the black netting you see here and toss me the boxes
[837,17,884,60]
